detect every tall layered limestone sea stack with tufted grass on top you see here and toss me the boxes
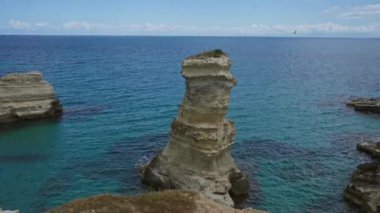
[142,50,249,206]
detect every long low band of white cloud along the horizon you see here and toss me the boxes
[2,19,380,36]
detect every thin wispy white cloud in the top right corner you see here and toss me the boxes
[324,4,380,19]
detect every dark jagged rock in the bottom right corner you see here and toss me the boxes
[344,139,380,213]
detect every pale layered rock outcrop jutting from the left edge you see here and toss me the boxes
[0,72,62,124]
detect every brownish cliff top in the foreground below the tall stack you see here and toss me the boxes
[49,190,264,213]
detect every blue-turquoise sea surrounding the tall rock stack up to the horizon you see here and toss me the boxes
[0,36,380,213]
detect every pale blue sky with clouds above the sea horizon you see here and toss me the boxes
[0,0,380,37]
